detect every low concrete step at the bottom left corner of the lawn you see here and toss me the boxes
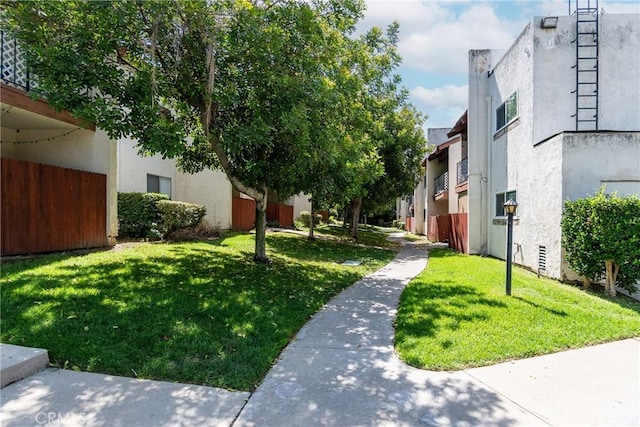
[0,344,49,388]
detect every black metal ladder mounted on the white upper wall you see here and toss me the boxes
[569,0,598,130]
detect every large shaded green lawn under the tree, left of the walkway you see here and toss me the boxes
[0,233,394,390]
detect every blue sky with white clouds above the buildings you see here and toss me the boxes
[359,0,640,129]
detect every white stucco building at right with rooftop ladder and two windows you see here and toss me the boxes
[468,9,640,279]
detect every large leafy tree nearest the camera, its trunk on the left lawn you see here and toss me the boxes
[2,0,363,261]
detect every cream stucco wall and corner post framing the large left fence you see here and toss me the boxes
[1,128,118,241]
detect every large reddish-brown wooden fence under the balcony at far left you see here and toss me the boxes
[0,158,107,255]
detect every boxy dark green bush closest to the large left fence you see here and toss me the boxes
[118,192,169,238]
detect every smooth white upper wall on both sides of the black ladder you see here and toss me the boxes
[532,14,640,144]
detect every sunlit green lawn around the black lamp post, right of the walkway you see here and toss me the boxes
[396,250,640,370]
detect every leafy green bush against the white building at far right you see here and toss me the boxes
[562,188,640,296]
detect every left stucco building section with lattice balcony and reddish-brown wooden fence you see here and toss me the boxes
[0,32,118,255]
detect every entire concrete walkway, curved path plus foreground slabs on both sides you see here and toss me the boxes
[0,239,640,427]
